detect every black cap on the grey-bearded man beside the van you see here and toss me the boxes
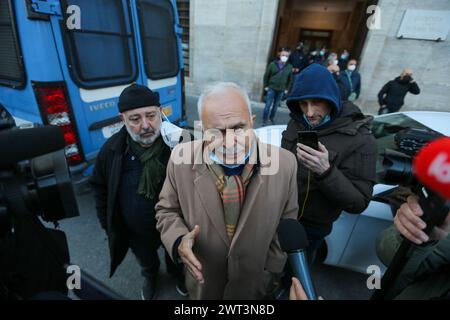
[119,84,161,113]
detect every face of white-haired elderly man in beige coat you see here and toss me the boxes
[202,88,256,165]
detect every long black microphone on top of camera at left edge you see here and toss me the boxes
[0,126,65,166]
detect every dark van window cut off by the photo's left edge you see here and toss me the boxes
[0,0,25,87]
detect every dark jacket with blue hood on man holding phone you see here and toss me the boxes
[281,64,377,227]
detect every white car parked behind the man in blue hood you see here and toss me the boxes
[255,111,450,273]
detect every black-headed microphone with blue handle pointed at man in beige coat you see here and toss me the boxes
[278,219,317,300]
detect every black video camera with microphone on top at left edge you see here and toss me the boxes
[0,108,79,237]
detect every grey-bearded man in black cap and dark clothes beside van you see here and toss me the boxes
[91,84,186,300]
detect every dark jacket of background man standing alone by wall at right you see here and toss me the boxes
[378,77,420,112]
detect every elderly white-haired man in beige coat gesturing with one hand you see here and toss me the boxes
[156,83,298,299]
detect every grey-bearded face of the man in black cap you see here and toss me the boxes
[121,106,161,148]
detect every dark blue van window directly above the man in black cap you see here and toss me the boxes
[63,0,137,88]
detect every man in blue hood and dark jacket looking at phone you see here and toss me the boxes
[281,64,377,261]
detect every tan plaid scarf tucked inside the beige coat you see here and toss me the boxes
[207,163,254,240]
